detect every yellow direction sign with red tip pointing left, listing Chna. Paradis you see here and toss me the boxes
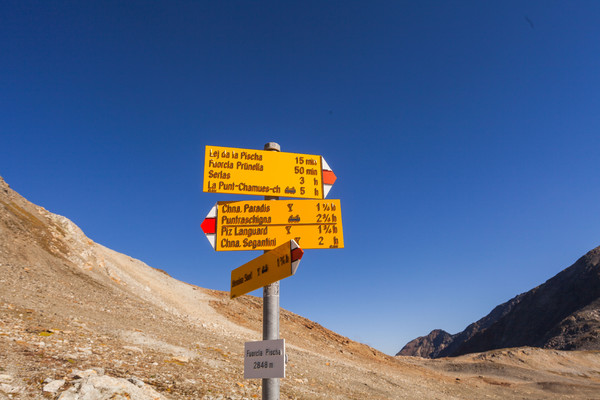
[201,200,344,251]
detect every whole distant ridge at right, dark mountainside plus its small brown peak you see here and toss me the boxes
[396,247,600,358]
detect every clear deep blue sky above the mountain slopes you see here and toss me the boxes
[0,0,600,354]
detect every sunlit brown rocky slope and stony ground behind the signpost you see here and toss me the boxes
[0,178,600,400]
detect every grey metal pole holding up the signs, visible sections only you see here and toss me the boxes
[262,142,281,400]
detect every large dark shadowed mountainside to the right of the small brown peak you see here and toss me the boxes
[440,247,600,357]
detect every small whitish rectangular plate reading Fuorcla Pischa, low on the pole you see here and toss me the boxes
[244,339,285,379]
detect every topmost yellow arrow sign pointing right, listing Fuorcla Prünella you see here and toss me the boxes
[202,146,336,199]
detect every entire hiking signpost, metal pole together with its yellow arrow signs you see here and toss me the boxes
[201,142,344,400]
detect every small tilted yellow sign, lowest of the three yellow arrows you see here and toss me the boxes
[231,240,304,299]
